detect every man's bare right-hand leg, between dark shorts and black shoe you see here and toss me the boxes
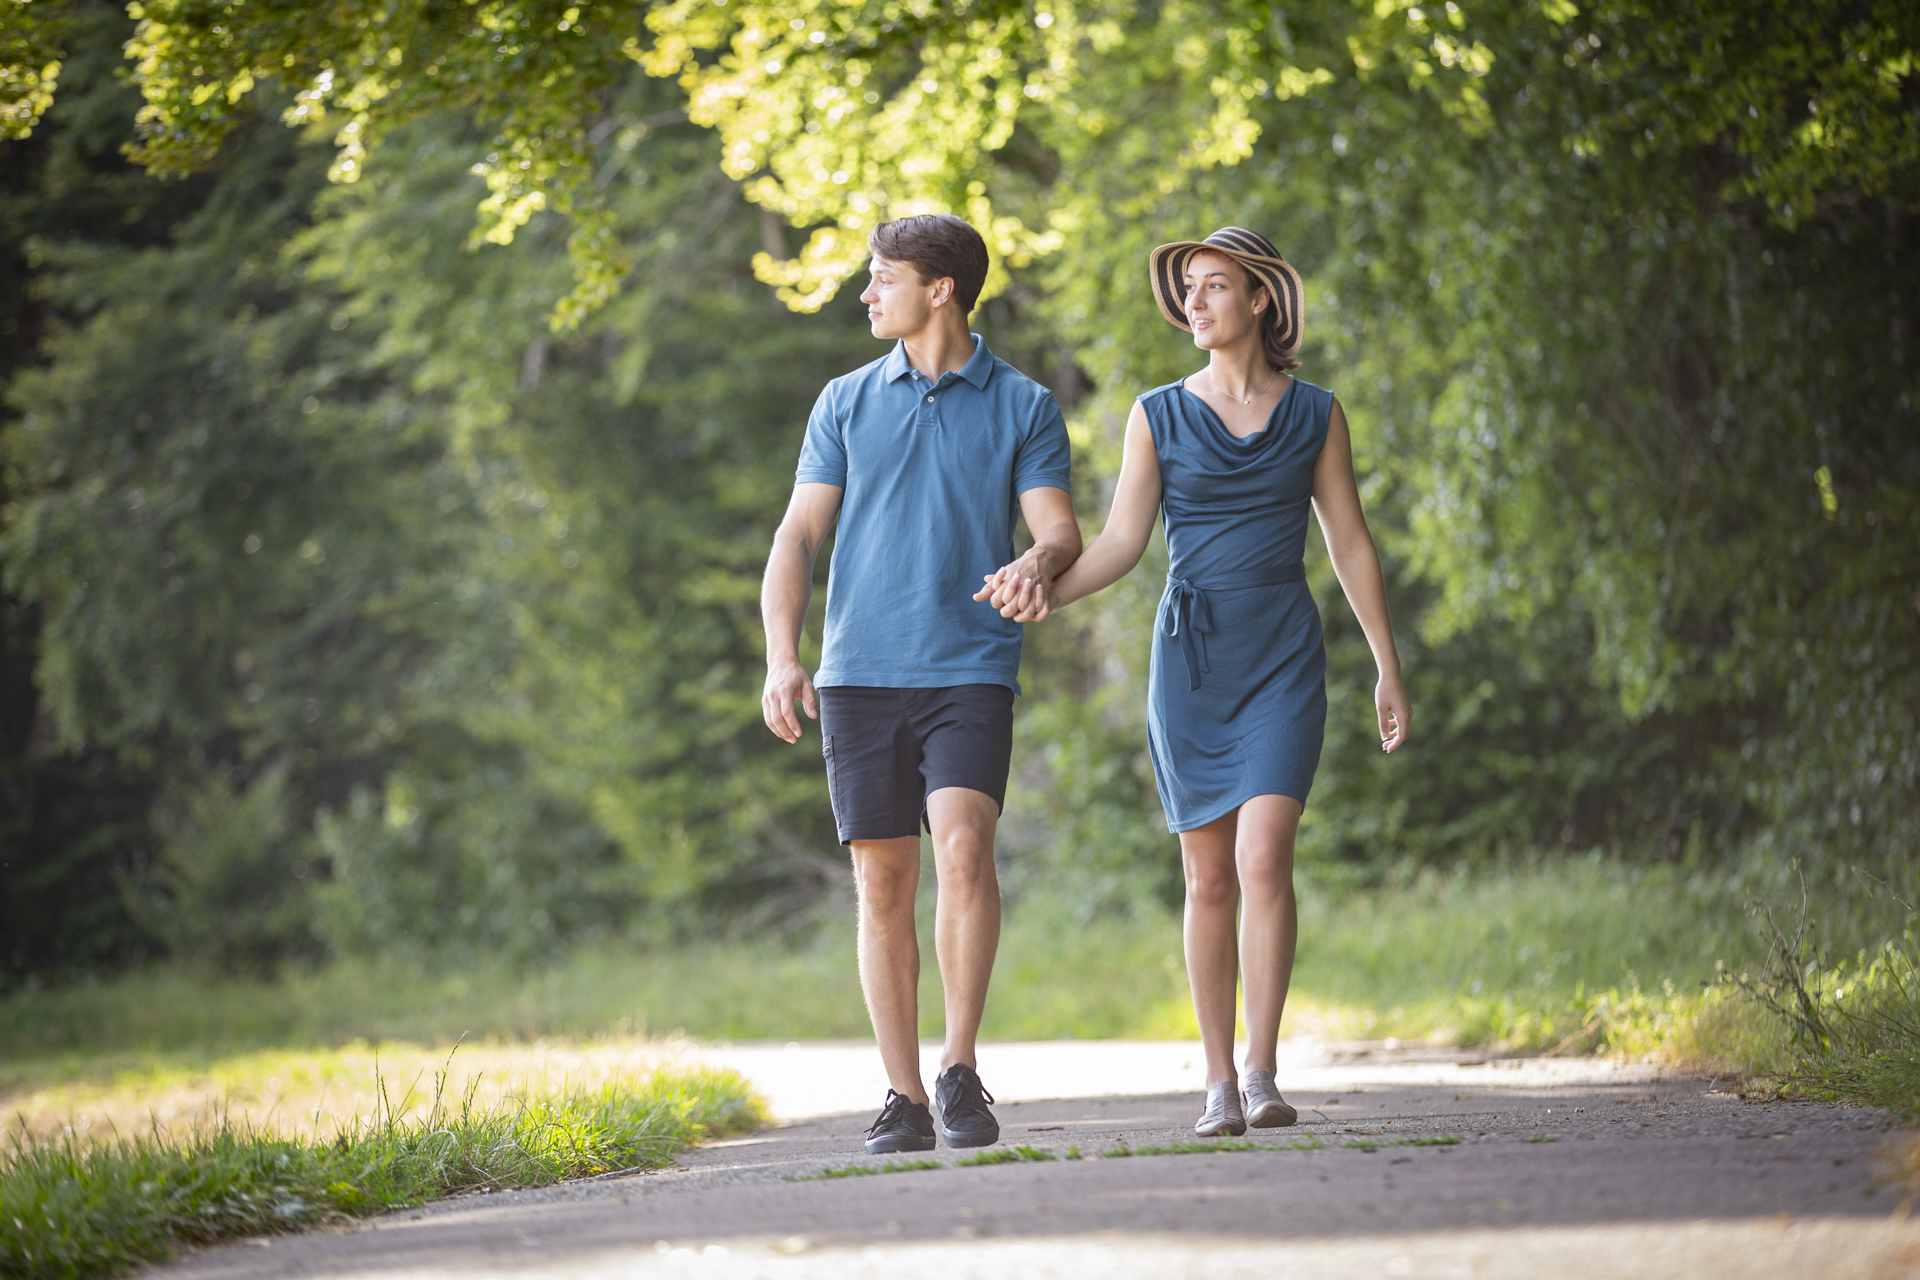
[925,787,1000,1088]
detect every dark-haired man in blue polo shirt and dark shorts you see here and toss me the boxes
[760,215,1081,1153]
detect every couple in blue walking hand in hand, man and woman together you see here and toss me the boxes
[760,215,1409,1153]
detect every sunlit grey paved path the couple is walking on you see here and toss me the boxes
[152,1040,1920,1280]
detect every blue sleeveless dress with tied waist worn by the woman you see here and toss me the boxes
[1140,378,1332,831]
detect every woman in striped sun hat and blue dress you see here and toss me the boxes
[975,226,1409,1136]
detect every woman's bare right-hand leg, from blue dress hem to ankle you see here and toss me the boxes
[1236,796,1300,1071]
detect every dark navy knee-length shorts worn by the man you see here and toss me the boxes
[820,685,1014,844]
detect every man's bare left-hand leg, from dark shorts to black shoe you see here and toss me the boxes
[852,837,927,1105]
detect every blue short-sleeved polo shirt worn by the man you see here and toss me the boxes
[793,334,1069,693]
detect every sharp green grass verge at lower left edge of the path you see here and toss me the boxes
[0,1071,766,1280]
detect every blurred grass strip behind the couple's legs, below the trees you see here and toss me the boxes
[0,860,1764,1092]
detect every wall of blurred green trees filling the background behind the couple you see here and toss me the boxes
[0,0,1920,981]
